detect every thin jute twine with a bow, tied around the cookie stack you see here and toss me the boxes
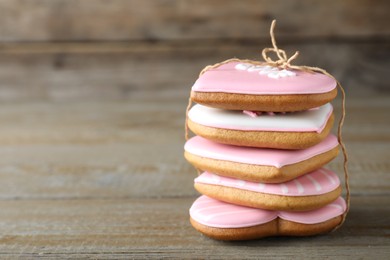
[185,20,350,231]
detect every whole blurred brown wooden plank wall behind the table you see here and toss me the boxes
[0,0,390,100]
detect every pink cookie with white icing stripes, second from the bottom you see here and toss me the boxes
[194,168,341,211]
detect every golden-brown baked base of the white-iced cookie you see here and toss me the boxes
[187,113,334,149]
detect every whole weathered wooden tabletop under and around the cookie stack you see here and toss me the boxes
[0,94,390,259]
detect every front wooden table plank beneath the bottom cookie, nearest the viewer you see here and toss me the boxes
[0,196,390,259]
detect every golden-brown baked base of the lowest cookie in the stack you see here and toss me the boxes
[190,216,342,240]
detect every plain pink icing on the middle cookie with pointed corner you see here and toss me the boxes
[184,135,338,168]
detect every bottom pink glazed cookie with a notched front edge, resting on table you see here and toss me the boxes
[190,196,346,240]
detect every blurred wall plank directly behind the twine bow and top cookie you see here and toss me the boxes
[0,41,390,101]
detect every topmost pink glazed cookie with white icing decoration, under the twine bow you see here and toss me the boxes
[191,61,337,112]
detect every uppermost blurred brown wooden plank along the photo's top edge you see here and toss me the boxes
[0,0,390,41]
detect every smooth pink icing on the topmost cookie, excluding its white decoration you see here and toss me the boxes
[192,62,336,95]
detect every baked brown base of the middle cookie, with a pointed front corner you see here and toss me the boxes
[184,146,339,183]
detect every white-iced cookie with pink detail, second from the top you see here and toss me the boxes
[187,103,334,149]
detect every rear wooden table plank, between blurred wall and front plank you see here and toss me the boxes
[0,97,390,199]
